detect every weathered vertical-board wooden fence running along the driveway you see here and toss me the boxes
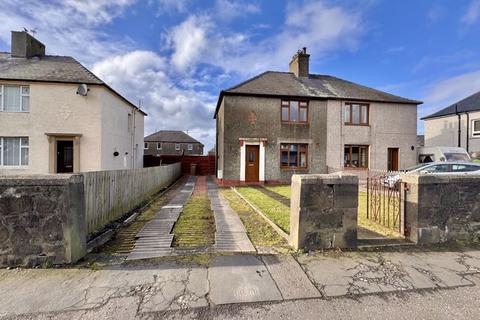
[82,163,182,234]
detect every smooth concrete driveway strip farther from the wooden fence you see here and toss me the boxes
[208,182,256,252]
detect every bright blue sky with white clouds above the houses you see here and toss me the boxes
[0,0,480,151]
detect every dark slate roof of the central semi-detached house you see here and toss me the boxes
[215,71,423,117]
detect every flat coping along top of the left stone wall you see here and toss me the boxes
[0,174,83,186]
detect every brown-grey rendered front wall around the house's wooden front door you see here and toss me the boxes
[218,96,327,181]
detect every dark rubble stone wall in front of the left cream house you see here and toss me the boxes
[0,175,86,266]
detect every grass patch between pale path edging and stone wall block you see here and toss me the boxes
[237,187,290,233]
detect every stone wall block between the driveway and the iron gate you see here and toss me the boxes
[290,173,358,250]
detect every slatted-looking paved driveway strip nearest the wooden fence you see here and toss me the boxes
[127,177,196,260]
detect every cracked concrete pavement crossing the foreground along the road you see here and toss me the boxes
[0,250,480,320]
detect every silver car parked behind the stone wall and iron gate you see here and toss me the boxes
[384,161,480,188]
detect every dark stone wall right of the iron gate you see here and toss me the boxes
[402,175,480,244]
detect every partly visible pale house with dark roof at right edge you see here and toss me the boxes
[422,92,480,153]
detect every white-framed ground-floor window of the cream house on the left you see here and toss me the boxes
[0,137,29,167]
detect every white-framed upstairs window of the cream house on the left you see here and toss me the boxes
[0,85,30,112]
